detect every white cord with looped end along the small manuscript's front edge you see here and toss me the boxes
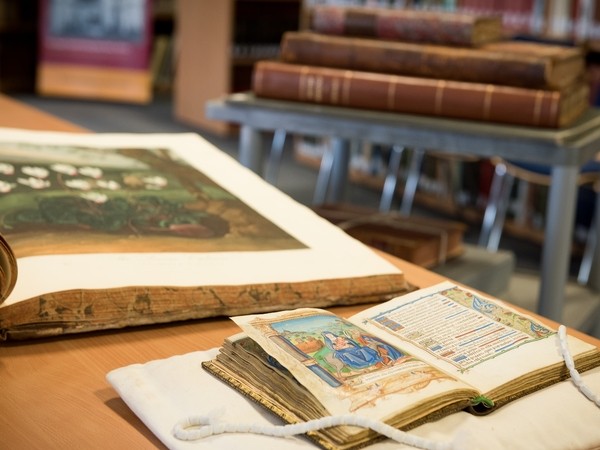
[173,414,451,450]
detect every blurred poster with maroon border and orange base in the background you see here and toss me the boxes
[36,0,152,103]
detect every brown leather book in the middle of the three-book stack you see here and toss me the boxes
[280,31,585,89]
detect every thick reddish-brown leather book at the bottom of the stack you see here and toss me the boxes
[252,60,589,128]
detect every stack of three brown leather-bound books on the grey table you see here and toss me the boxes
[252,5,589,128]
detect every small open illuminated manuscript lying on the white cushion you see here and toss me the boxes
[203,282,600,450]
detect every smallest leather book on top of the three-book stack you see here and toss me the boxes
[309,5,503,46]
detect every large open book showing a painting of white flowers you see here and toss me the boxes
[0,129,409,339]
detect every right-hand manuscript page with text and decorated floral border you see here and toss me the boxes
[351,282,593,393]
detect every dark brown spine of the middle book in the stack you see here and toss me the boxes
[280,32,550,88]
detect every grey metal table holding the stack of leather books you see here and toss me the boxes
[205,93,600,322]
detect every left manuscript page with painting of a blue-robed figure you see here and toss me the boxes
[233,308,477,419]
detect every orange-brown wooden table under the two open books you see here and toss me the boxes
[0,95,600,449]
